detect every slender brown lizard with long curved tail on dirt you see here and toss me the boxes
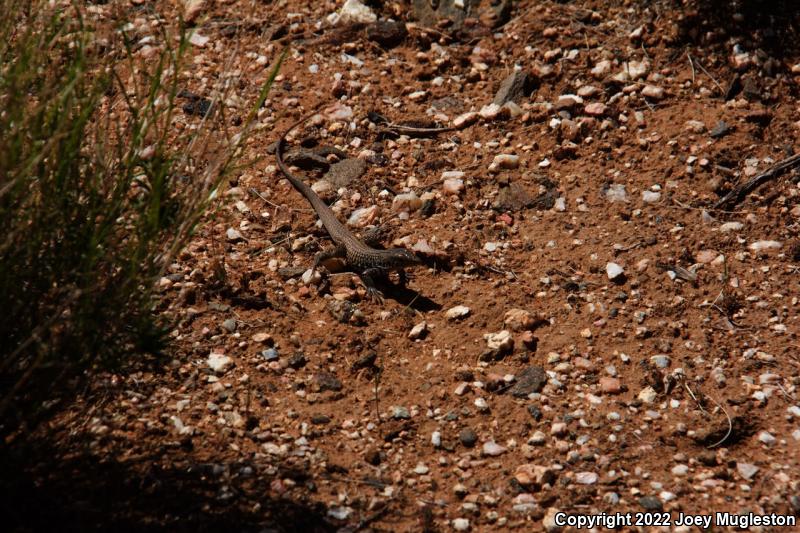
[275,110,422,302]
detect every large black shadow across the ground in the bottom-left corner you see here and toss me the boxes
[0,436,336,533]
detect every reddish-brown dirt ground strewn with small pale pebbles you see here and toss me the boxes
[3,0,800,531]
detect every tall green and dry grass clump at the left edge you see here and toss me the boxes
[0,0,280,434]
